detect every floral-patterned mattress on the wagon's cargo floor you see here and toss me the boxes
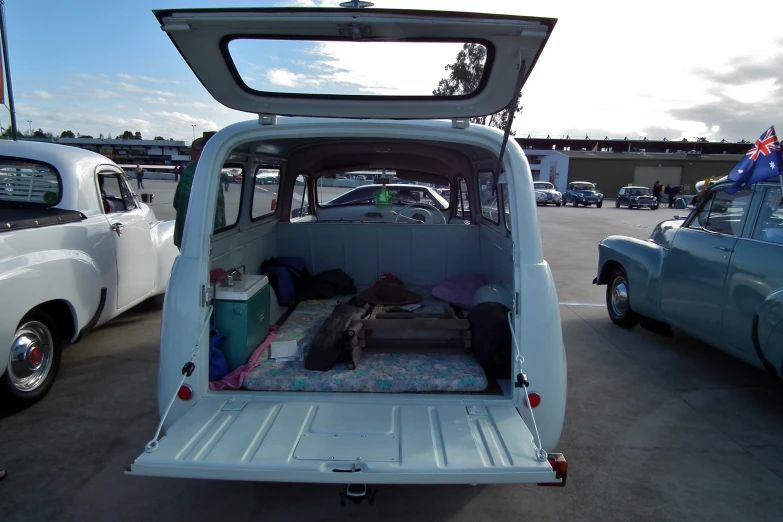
[242,298,488,393]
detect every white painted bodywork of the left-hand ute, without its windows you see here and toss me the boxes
[0,141,178,406]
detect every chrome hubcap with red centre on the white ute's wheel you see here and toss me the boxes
[8,321,54,392]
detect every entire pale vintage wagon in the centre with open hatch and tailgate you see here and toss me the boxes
[128,8,567,490]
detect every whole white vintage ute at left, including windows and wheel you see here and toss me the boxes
[0,140,179,409]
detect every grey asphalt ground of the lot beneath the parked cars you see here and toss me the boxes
[0,192,783,522]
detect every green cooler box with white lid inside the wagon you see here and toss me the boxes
[215,274,270,371]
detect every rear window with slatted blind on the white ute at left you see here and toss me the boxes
[0,158,62,205]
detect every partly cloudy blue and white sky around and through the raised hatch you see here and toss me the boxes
[6,0,783,141]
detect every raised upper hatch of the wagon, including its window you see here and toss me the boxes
[154,8,555,119]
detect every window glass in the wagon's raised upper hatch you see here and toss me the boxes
[228,38,487,97]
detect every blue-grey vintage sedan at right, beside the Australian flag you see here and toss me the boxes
[593,178,783,378]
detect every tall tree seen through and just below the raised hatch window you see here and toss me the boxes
[432,44,522,136]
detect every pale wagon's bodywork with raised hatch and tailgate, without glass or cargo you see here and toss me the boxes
[128,4,566,485]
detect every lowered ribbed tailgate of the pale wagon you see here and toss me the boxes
[128,393,561,484]
